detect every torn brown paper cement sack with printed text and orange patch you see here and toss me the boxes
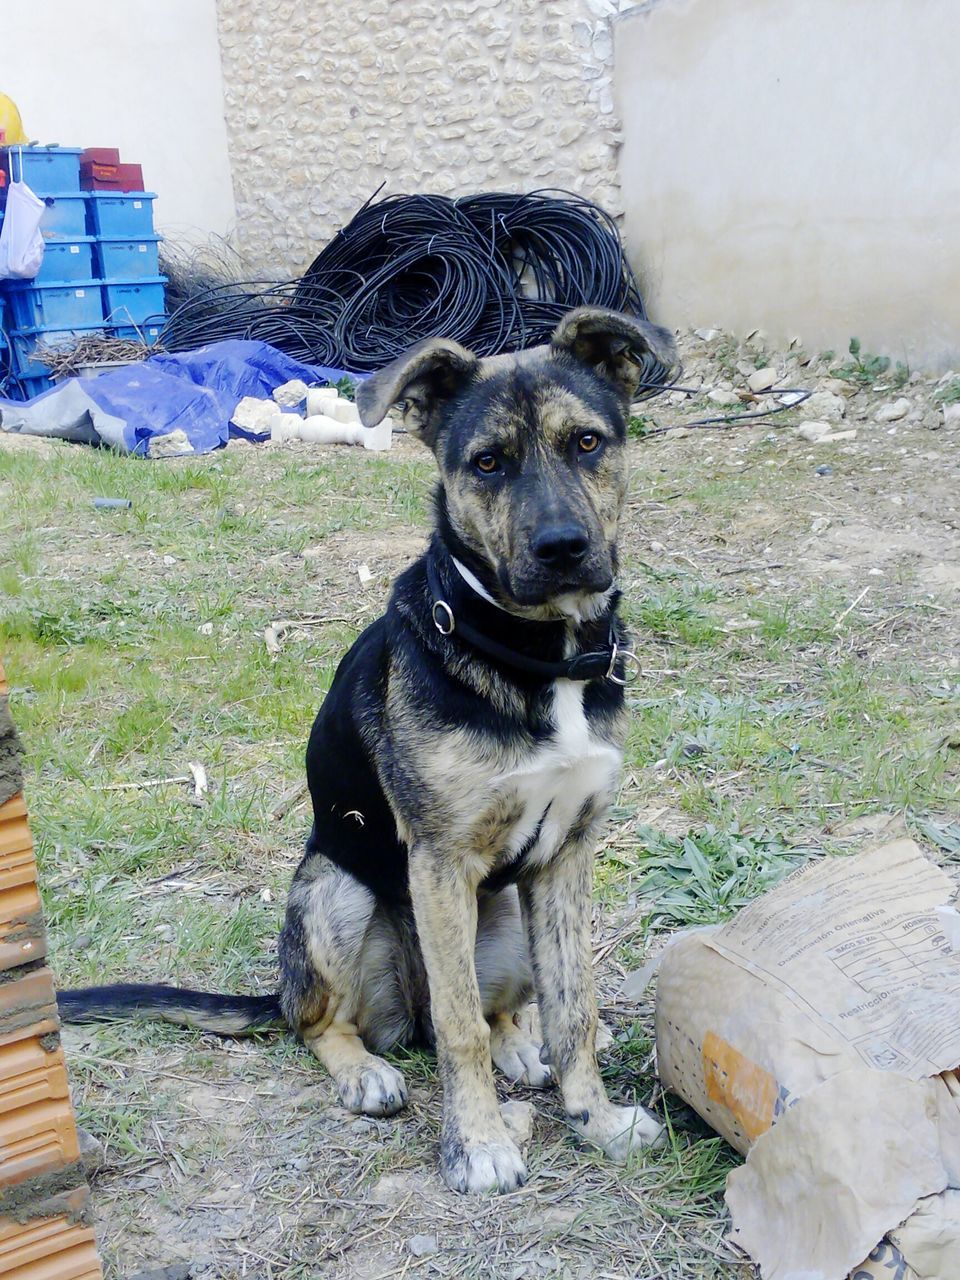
[657,840,960,1280]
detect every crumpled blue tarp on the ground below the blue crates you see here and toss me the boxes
[0,339,355,457]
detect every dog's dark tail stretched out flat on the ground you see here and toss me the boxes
[56,982,287,1036]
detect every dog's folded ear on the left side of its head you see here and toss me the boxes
[357,338,480,448]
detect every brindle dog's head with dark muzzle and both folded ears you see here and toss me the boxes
[357,307,675,617]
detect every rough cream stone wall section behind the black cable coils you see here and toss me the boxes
[218,0,636,278]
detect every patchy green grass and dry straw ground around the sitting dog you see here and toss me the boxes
[0,422,960,1280]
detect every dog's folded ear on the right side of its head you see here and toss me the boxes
[550,307,677,399]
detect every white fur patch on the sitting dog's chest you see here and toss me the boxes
[492,680,622,864]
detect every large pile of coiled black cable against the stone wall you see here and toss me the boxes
[159,191,667,394]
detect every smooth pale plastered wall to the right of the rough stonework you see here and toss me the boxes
[614,0,960,365]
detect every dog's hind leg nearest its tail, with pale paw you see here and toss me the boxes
[279,855,407,1116]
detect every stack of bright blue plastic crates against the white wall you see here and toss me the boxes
[0,147,165,399]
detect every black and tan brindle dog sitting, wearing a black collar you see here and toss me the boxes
[59,307,675,1192]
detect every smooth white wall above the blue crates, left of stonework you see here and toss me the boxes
[0,0,236,242]
